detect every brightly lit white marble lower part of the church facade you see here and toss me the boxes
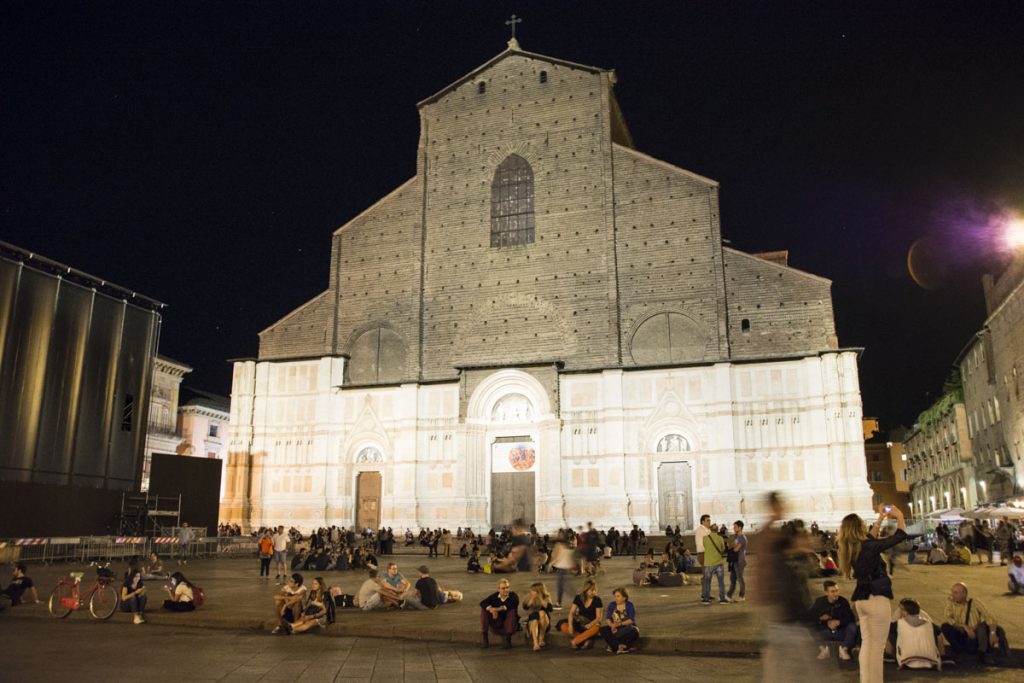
[221,350,871,532]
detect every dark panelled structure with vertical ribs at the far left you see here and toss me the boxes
[0,243,164,537]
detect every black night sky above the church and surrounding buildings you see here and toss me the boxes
[0,0,1024,427]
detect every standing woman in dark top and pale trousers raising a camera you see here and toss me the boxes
[839,505,906,683]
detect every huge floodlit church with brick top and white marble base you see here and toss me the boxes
[221,39,870,531]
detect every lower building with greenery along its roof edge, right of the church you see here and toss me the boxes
[905,384,978,517]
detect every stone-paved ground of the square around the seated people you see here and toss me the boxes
[0,555,1024,681]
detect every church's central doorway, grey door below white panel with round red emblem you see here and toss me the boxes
[490,437,537,530]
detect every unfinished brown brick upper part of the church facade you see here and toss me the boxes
[259,49,838,384]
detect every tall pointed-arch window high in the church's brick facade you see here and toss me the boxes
[490,155,534,247]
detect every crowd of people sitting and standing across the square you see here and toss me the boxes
[0,496,1024,681]
